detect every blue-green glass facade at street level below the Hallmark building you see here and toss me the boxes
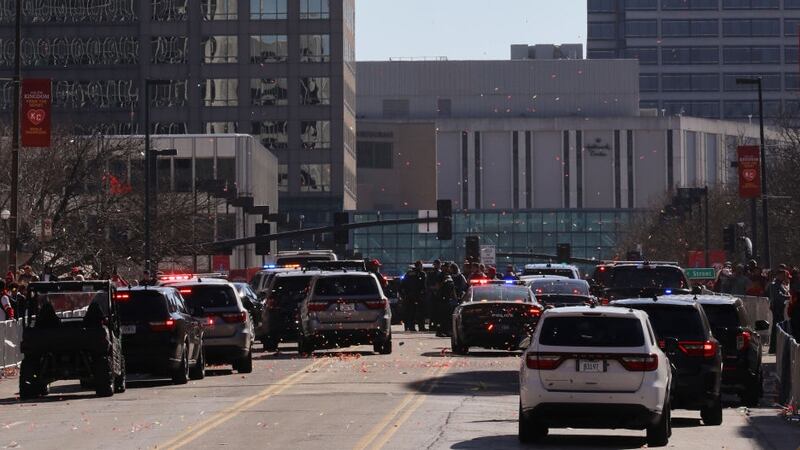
[351,209,643,275]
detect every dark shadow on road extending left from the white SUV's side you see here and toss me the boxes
[407,370,519,396]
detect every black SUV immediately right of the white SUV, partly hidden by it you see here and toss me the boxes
[611,295,722,425]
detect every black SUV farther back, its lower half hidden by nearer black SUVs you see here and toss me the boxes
[592,261,699,304]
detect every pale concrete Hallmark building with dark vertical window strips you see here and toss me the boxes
[358,60,758,211]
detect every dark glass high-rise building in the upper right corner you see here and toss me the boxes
[587,0,800,120]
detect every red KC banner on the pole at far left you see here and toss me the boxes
[20,79,52,147]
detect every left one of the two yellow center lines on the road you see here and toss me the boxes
[156,358,330,449]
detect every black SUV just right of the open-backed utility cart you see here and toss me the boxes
[114,287,205,384]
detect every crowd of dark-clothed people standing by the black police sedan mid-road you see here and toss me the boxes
[399,259,518,337]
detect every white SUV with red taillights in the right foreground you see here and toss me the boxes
[519,306,672,447]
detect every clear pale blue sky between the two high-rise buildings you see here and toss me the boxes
[356,0,586,61]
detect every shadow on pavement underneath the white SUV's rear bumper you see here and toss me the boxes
[450,430,646,450]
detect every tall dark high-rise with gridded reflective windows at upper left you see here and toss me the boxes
[0,0,356,223]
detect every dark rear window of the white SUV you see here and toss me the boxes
[539,316,644,347]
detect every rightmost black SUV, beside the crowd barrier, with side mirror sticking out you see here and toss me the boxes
[697,295,769,406]
